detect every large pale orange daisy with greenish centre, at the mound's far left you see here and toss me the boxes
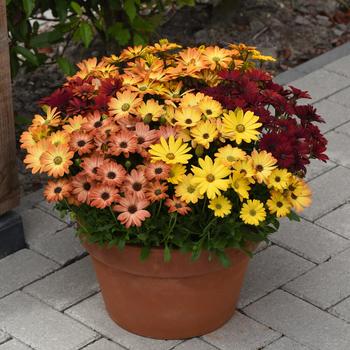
[40,145,74,177]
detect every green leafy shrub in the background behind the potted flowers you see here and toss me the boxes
[6,0,195,76]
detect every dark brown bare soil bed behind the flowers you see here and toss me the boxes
[13,0,350,193]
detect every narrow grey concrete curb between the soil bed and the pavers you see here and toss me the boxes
[274,42,350,85]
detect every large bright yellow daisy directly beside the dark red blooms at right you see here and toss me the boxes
[221,108,262,145]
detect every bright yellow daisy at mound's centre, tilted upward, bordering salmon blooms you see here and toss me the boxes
[148,135,192,164]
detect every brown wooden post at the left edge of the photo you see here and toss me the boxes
[0,0,20,215]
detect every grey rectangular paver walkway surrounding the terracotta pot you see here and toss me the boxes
[0,47,350,350]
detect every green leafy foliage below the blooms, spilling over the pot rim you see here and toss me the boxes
[56,183,284,267]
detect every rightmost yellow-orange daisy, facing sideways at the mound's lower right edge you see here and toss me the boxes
[283,176,312,213]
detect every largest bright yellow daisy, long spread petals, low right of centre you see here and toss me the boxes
[192,156,231,199]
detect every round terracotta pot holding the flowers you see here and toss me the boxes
[84,243,256,339]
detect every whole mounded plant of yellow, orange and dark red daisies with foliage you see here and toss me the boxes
[21,40,327,264]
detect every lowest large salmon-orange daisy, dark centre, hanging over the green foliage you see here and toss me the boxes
[113,196,151,228]
